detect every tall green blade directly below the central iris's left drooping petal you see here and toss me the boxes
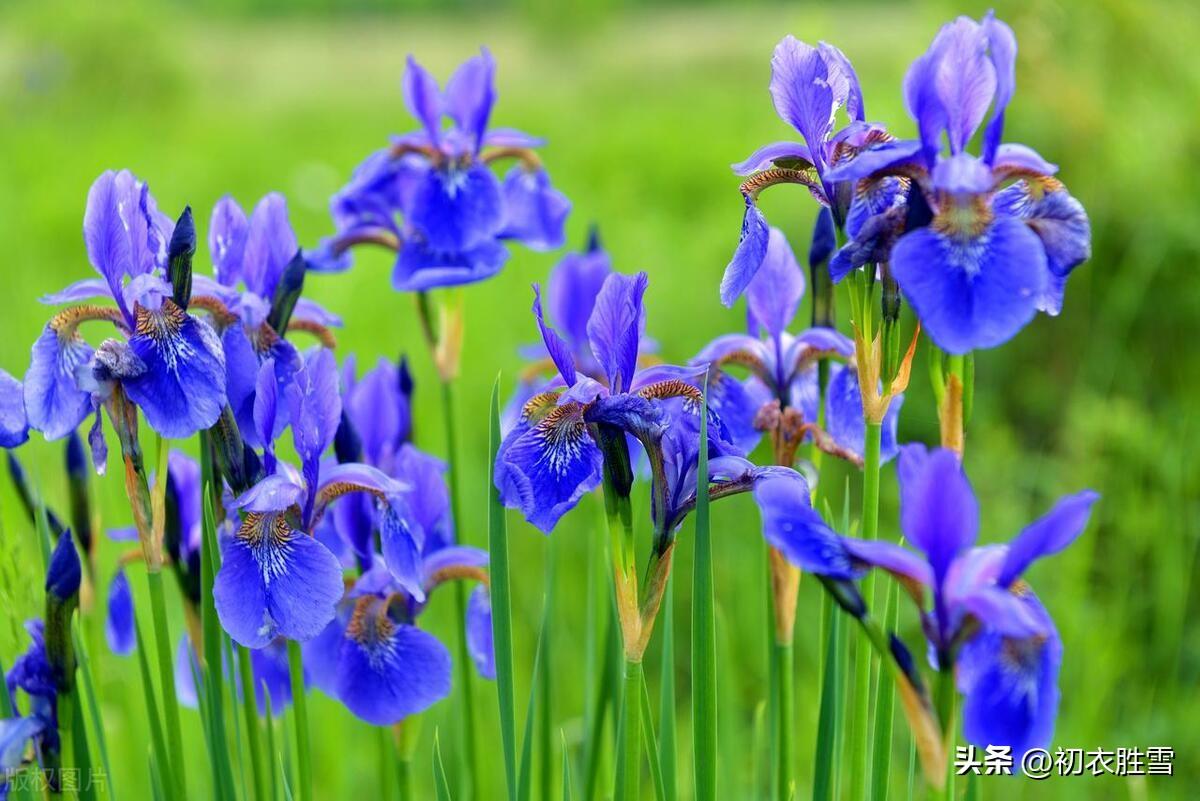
[487,375,517,801]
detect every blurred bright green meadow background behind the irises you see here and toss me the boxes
[0,0,1200,800]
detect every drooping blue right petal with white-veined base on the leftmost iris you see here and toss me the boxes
[122,300,226,439]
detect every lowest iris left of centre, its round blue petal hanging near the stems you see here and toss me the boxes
[305,546,496,725]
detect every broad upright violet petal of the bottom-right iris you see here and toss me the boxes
[899,446,979,584]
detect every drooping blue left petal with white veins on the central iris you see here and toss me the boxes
[496,403,601,534]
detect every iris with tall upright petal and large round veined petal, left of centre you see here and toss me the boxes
[212,349,403,648]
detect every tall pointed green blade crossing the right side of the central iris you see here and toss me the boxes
[691,378,718,801]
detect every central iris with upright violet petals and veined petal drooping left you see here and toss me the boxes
[496,272,703,534]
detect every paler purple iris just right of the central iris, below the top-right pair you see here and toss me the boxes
[692,228,904,460]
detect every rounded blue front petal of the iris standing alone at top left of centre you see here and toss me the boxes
[406,164,504,253]
